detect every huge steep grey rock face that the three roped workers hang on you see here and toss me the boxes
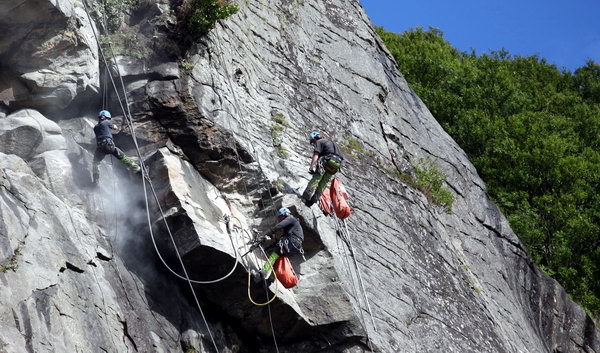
[0,0,600,353]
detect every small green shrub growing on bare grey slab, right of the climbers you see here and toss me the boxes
[394,158,454,214]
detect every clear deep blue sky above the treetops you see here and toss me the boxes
[360,0,600,71]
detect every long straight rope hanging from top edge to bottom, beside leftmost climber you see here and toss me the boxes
[82,0,219,352]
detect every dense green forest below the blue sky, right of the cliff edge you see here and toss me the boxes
[377,28,600,319]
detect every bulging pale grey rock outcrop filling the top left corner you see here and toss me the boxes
[0,0,99,111]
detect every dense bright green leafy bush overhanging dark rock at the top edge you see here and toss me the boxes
[183,0,239,36]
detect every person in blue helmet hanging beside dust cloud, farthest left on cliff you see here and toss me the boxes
[92,110,140,184]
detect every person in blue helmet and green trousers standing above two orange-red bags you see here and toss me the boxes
[301,131,344,207]
